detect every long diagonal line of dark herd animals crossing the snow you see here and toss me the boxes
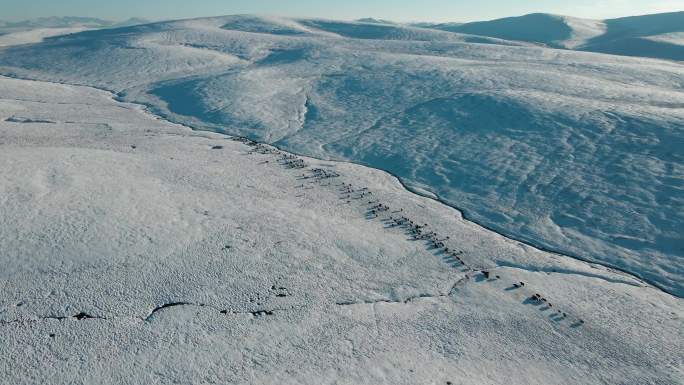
[234,138,585,327]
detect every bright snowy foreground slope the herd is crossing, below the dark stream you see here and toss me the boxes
[0,78,684,385]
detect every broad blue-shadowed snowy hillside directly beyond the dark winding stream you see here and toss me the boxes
[0,16,684,296]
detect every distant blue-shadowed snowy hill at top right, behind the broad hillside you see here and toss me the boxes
[429,12,684,61]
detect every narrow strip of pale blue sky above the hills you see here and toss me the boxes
[0,0,684,21]
